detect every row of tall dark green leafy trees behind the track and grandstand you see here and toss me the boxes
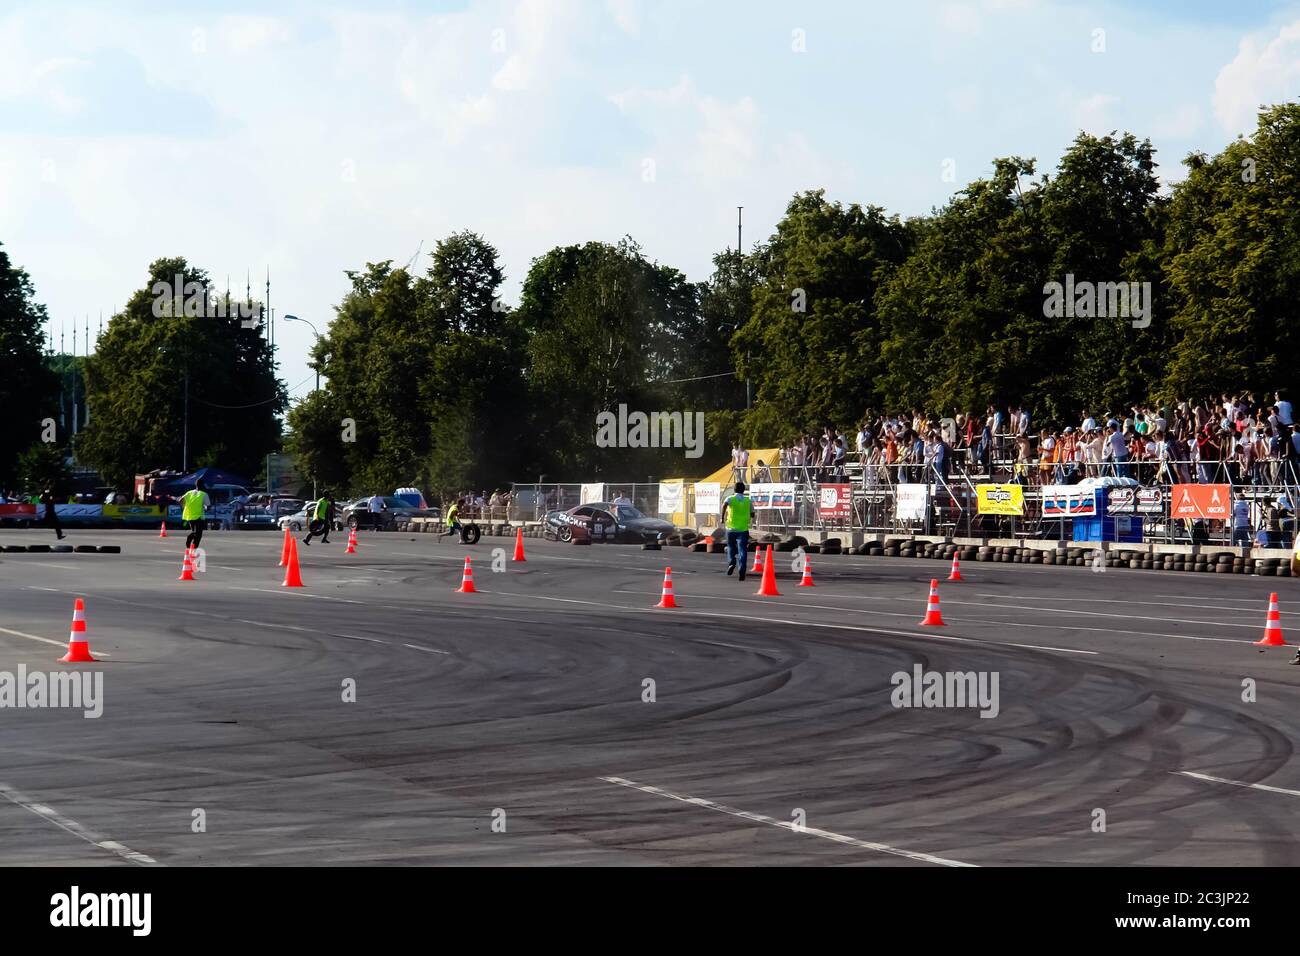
[0,104,1300,494]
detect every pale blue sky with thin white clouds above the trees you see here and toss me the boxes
[0,0,1300,397]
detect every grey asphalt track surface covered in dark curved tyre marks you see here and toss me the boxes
[0,531,1300,866]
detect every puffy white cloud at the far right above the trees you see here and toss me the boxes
[1214,21,1300,134]
